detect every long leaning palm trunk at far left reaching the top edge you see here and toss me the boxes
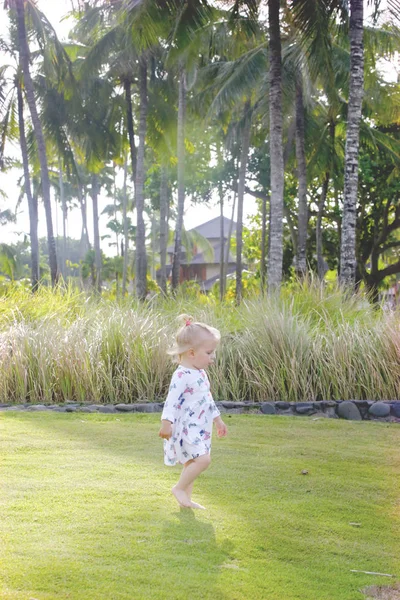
[15,0,58,286]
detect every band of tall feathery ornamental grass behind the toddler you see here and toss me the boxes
[0,283,400,403]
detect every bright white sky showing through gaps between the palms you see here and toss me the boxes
[0,0,397,255]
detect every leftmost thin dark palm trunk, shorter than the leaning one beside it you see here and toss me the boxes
[17,77,40,292]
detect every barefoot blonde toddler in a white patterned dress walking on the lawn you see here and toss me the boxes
[159,315,227,508]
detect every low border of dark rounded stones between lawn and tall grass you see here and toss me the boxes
[0,400,400,423]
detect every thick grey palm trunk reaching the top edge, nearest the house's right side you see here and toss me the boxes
[268,0,284,292]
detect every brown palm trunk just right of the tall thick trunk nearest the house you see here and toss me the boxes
[296,75,308,278]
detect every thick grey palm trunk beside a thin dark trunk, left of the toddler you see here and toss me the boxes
[135,54,148,300]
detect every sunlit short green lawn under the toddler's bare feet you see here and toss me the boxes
[0,413,400,600]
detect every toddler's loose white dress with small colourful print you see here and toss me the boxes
[161,366,220,467]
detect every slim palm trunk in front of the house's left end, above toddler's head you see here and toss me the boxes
[172,67,186,293]
